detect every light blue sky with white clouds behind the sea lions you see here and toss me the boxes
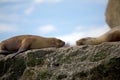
[0,0,109,45]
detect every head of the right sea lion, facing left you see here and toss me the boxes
[76,37,95,46]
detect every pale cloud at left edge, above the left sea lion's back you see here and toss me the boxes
[0,24,17,32]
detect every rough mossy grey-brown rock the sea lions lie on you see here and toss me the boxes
[0,42,120,80]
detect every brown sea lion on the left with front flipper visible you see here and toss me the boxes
[0,35,65,57]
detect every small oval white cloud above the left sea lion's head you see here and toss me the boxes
[37,25,56,34]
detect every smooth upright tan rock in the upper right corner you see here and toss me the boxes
[106,0,120,28]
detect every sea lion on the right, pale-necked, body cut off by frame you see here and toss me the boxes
[76,26,120,46]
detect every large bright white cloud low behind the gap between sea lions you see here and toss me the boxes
[57,25,109,45]
